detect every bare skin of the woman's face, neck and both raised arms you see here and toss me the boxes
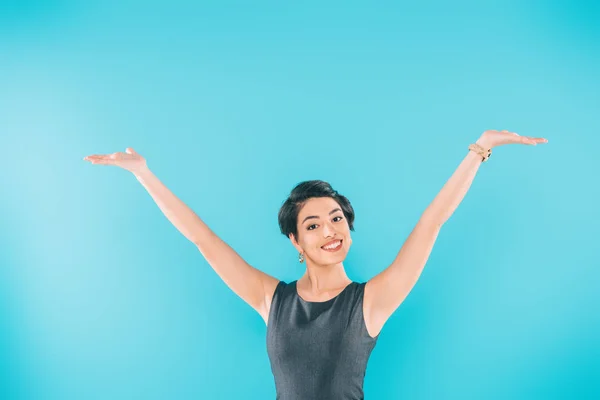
[84,130,548,337]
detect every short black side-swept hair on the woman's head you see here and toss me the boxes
[278,180,354,240]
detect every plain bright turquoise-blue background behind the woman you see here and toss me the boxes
[0,0,600,400]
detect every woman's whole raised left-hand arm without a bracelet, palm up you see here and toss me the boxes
[84,148,279,323]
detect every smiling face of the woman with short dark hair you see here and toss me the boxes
[290,197,352,266]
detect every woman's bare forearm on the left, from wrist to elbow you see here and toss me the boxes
[134,167,215,245]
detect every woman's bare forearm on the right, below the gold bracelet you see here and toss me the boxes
[422,139,489,226]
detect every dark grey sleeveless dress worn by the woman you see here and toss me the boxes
[267,281,379,400]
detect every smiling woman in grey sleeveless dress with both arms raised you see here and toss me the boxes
[84,130,548,400]
